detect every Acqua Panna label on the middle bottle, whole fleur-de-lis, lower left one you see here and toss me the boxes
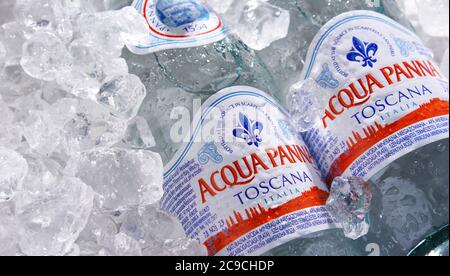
[162,86,335,256]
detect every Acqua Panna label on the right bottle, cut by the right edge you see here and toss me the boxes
[303,11,449,182]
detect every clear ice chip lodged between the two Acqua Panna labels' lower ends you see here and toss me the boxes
[327,177,372,240]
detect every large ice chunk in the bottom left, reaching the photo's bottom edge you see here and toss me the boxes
[16,177,94,256]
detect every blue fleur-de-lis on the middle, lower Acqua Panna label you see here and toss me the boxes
[233,113,264,147]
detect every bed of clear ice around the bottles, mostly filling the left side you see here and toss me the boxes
[0,0,448,255]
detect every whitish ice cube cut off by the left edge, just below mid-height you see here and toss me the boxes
[0,148,28,202]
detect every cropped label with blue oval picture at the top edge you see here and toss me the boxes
[130,0,228,54]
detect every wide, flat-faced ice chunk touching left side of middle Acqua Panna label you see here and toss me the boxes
[65,148,163,210]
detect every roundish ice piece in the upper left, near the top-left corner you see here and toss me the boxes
[20,32,72,81]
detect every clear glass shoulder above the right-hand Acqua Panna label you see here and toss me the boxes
[258,0,412,100]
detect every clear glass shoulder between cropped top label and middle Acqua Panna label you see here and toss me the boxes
[124,36,279,164]
